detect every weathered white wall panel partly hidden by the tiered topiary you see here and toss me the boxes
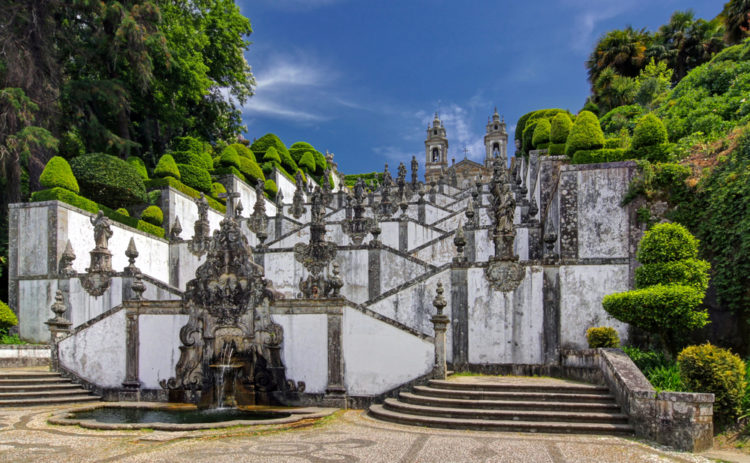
[560,264,629,349]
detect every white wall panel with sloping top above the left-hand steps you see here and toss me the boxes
[59,310,126,387]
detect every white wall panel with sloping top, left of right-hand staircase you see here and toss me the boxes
[342,308,435,396]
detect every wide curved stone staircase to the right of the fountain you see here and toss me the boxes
[369,376,633,435]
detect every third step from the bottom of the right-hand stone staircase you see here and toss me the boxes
[399,392,620,413]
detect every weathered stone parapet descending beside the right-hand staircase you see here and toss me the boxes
[561,349,714,452]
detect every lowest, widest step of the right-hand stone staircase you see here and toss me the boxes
[369,405,633,436]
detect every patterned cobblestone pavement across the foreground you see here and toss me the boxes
[0,407,720,463]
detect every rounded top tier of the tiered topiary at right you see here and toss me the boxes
[636,223,698,264]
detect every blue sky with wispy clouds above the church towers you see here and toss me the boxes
[238,0,723,173]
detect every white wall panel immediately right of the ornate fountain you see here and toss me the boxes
[271,314,328,393]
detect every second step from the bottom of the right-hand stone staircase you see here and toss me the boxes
[383,399,628,424]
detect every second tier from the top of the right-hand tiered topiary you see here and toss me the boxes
[635,259,711,291]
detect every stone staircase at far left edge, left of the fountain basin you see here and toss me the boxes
[0,368,101,407]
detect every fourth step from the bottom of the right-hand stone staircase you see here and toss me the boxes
[414,386,614,403]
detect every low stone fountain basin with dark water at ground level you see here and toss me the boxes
[48,403,336,431]
